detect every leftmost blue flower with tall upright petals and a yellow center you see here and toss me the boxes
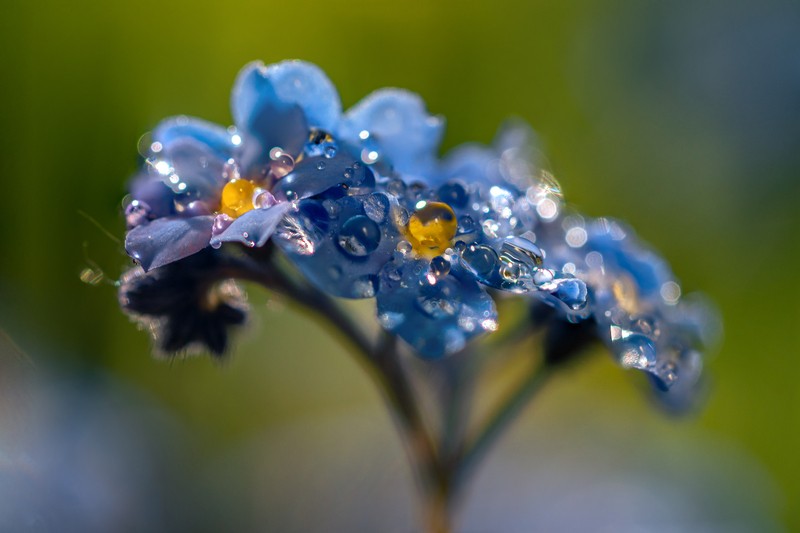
[125,61,441,270]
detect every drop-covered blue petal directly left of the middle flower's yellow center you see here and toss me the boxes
[273,193,401,298]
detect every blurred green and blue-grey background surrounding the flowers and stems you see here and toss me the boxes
[0,0,800,531]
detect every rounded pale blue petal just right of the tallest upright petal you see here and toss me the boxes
[337,89,444,175]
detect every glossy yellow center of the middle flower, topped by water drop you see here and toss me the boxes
[406,202,458,257]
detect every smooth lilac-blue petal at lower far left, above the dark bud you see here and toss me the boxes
[125,216,214,271]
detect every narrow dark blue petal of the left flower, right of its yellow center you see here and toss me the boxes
[272,154,375,200]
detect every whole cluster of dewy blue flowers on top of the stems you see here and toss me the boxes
[123,61,720,406]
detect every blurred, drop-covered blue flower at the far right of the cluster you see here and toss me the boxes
[540,214,719,407]
